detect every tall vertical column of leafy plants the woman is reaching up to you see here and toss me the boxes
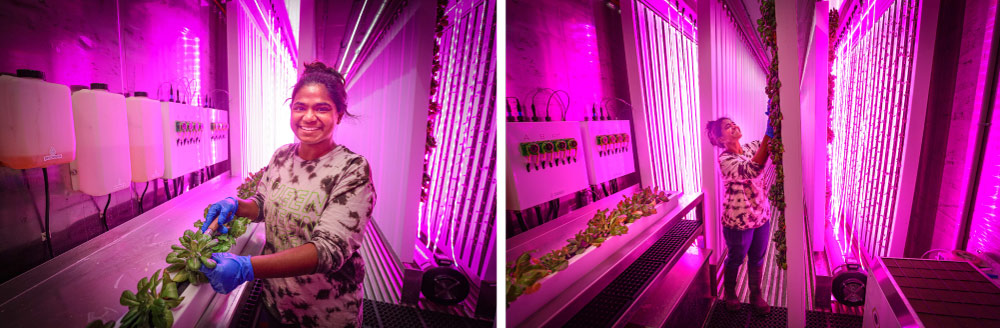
[757,0,788,270]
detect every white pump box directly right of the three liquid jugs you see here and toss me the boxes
[160,102,204,179]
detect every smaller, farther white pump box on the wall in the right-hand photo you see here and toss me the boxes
[580,120,635,185]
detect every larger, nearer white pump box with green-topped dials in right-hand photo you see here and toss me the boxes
[507,121,589,210]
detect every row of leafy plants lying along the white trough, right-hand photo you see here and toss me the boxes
[506,188,670,306]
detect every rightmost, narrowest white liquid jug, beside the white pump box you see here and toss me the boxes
[125,92,163,182]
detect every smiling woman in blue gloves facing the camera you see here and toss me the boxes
[201,62,375,327]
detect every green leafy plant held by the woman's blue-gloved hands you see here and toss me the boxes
[167,230,219,286]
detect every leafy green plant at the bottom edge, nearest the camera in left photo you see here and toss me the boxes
[118,270,184,328]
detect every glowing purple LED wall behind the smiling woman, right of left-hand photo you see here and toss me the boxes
[417,1,496,279]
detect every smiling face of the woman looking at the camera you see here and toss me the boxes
[292,83,340,144]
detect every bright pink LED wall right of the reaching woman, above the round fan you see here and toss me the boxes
[829,1,916,256]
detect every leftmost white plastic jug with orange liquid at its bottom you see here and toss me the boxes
[0,70,76,169]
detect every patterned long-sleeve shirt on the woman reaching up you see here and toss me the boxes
[719,140,770,230]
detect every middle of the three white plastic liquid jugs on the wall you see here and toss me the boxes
[70,83,132,196]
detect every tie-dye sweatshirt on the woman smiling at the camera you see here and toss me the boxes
[254,143,375,327]
